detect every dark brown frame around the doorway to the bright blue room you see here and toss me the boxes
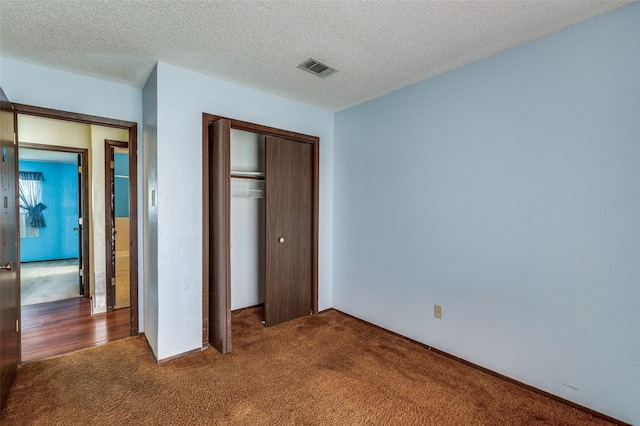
[16,141,92,297]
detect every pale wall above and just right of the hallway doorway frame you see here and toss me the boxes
[0,57,145,331]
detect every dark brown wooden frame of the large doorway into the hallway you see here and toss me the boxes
[13,103,139,336]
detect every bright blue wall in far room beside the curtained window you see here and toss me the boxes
[19,160,78,262]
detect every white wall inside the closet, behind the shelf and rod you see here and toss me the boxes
[230,129,265,310]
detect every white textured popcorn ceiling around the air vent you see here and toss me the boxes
[0,0,633,110]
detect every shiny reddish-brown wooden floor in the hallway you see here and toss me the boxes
[21,297,130,362]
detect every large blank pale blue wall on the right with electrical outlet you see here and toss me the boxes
[333,4,640,424]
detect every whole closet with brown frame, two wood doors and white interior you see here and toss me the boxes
[203,114,319,353]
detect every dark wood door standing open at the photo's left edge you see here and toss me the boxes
[0,85,20,412]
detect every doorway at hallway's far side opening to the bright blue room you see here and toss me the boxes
[18,143,90,306]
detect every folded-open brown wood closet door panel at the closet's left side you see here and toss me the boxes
[208,119,231,354]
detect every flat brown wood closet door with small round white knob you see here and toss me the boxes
[265,137,314,326]
